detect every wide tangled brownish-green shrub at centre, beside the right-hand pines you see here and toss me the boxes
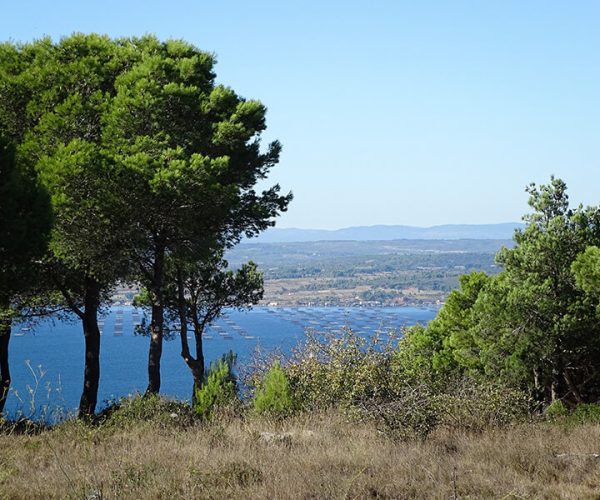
[276,330,530,438]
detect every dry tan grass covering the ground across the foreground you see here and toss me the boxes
[0,415,600,499]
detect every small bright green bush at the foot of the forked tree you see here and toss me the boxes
[194,352,237,420]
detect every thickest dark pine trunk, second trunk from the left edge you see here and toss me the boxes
[78,278,100,419]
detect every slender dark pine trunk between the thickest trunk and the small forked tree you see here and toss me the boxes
[146,248,165,395]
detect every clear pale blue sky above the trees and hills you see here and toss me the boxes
[0,0,600,228]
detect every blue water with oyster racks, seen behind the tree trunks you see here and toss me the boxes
[5,306,435,419]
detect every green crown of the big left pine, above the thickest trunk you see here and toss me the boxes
[0,34,131,285]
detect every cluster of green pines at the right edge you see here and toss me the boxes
[399,178,600,406]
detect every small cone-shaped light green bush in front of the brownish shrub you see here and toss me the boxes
[253,361,294,418]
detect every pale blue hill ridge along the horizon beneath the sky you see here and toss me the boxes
[251,222,523,243]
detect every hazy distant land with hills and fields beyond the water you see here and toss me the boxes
[227,223,522,306]
